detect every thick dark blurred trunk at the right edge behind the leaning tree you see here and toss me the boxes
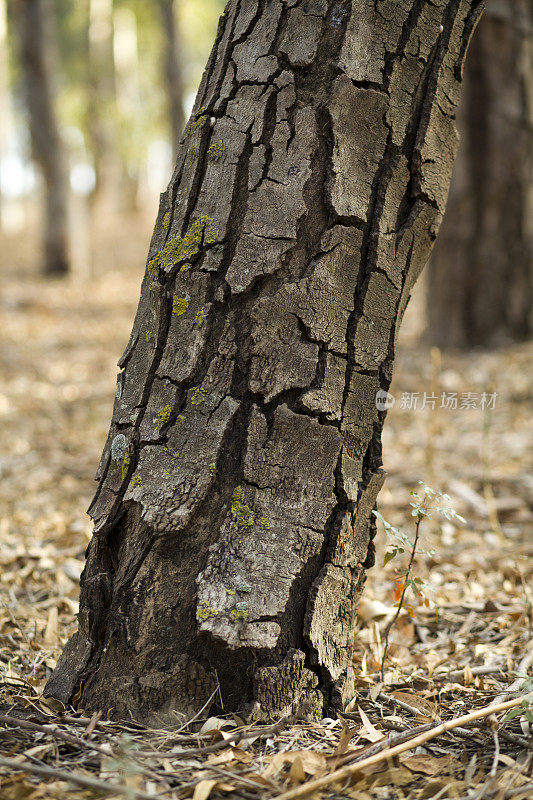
[428,0,533,347]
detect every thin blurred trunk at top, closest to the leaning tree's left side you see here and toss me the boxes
[159,0,185,158]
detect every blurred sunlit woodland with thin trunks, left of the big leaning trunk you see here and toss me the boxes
[0,0,224,277]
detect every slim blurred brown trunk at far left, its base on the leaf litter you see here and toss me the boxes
[14,0,69,276]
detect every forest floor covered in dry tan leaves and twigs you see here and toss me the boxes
[0,219,533,800]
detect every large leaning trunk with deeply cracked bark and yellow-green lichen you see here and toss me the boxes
[47,0,481,719]
